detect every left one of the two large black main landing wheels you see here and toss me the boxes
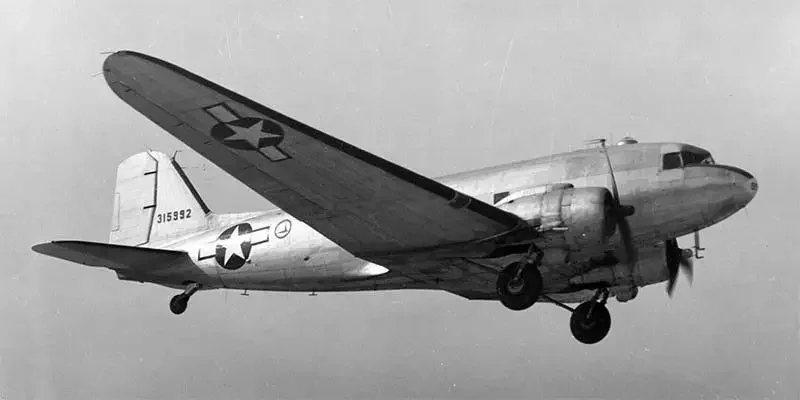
[497,263,542,311]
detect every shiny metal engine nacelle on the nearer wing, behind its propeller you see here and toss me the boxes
[497,185,616,248]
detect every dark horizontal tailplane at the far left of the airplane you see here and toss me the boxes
[32,240,190,272]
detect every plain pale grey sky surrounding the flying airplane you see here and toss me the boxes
[0,0,800,399]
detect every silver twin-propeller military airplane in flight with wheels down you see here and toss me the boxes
[32,51,758,344]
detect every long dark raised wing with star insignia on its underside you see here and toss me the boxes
[103,51,524,260]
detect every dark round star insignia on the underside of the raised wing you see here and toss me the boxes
[211,117,286,150]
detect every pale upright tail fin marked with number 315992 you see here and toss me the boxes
[110,151,210,246]
